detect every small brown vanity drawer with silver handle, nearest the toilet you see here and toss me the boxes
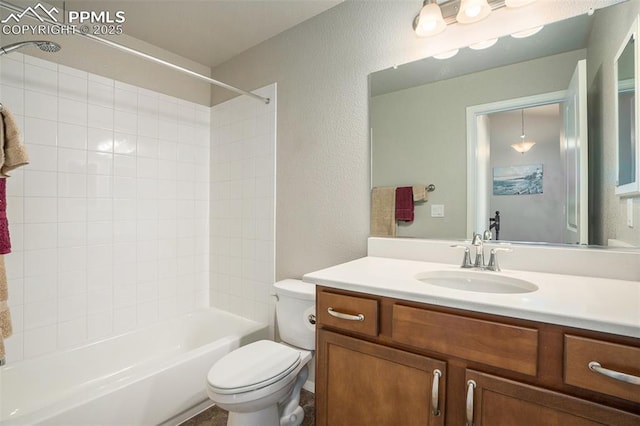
[317,290,378,337]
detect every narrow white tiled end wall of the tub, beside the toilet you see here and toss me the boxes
[210,84,276,331]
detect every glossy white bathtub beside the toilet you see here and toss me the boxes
[0,309,268,426]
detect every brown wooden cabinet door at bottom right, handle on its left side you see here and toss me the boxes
[466,370,640,426]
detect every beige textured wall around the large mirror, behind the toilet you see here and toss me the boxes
[206,0,611,278]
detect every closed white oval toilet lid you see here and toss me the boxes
[207,340,300,394]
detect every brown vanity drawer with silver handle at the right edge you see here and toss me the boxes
[564,334,640,403]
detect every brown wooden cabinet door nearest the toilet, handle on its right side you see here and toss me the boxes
[316,330,447,426]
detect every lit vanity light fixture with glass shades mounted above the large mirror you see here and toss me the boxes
[413,0,536,37]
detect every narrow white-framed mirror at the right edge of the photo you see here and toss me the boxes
[614,15,640,195]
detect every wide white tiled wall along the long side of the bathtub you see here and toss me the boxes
[0,53,210,362]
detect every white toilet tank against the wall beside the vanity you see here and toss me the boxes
[273,279,316,350]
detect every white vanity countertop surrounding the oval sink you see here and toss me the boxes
[302,256,640,338]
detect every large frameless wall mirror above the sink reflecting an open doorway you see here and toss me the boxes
[369,1,640,247]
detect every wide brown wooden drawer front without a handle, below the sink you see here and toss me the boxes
[392,304,538,376]
